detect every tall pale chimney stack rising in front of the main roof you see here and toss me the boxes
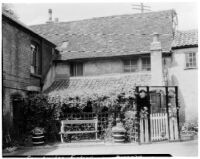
[150,33,164,86]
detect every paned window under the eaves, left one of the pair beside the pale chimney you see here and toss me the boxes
[124,59,138,72]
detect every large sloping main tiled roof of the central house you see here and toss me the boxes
[31,10,175,60]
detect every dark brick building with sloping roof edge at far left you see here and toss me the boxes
[2,12,57,138]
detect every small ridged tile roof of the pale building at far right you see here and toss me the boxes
[172,30,198,48]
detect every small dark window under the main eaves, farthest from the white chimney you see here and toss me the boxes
[70,63,83,76]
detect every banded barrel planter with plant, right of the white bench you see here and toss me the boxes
[112,118,126,143]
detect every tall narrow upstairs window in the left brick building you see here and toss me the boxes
[31,43,40,74]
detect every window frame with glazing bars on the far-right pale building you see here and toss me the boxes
[185,51,197,69]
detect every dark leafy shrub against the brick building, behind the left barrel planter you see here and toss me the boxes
[24,94,60,141]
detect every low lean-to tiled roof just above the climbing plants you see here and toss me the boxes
[44,72,151,95]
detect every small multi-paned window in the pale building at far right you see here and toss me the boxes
[185,52,197,68]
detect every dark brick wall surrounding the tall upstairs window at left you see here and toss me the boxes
[2,18,55,131]
